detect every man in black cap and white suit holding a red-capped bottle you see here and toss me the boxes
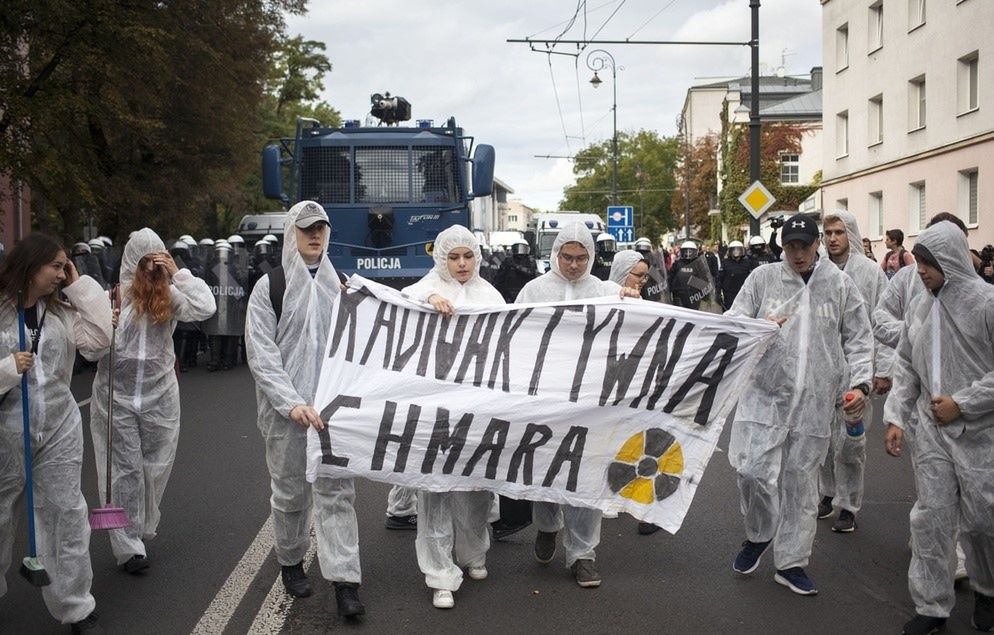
[726,215,873,595]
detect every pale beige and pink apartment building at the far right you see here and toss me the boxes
[821,0,994,253]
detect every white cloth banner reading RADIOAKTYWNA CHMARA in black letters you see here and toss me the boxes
[307,276,777,532]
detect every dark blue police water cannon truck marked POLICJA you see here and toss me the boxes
[262,95,494,288]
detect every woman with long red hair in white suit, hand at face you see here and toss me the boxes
[90,227,216,573]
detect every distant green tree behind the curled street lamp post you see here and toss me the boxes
[559,130,678,243]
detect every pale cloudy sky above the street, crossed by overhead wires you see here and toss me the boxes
[287,0,822,210]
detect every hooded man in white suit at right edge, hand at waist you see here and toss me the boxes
[884,222,994,635]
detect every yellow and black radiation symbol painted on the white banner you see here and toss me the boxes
[607,428,683,505]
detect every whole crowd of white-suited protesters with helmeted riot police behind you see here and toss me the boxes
[0,201,994,635]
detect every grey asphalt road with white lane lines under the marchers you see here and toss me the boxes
[0,366,975,635]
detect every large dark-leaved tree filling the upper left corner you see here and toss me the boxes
[0,0,305,243]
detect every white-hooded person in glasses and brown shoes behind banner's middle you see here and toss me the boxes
[515,222,638,588]
